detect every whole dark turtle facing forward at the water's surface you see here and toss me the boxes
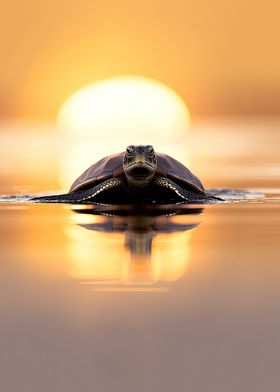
[33,145,221,204]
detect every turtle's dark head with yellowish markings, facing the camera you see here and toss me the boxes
[123,145,157,186]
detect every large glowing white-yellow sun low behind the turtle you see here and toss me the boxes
[57,76,190,143]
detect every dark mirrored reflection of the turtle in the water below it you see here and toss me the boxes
[73,205,203,278]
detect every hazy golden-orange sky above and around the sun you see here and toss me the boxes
[0,0,280,119]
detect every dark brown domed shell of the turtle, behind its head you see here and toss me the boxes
[70,152,206,195]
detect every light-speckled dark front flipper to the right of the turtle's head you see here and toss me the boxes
[155,177,222,203]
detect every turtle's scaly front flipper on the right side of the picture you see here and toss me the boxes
[155,177,221,203]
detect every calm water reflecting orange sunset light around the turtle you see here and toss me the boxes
[0,123,280,392]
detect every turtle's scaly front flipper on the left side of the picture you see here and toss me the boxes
[31,178,123,204]
